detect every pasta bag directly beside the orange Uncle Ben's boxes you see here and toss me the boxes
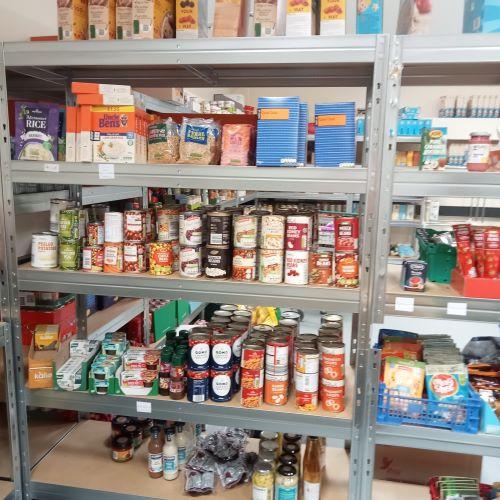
[148,118,179,163]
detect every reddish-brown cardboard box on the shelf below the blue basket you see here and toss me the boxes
[374,445,482,484]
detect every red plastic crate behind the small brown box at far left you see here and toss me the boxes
[21,300,77,345]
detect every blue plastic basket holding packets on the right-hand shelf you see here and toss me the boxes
[377,384,481,434]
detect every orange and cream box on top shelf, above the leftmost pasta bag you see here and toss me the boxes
[132,0,176,39]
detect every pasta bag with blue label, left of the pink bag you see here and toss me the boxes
[179,118,220,165]
